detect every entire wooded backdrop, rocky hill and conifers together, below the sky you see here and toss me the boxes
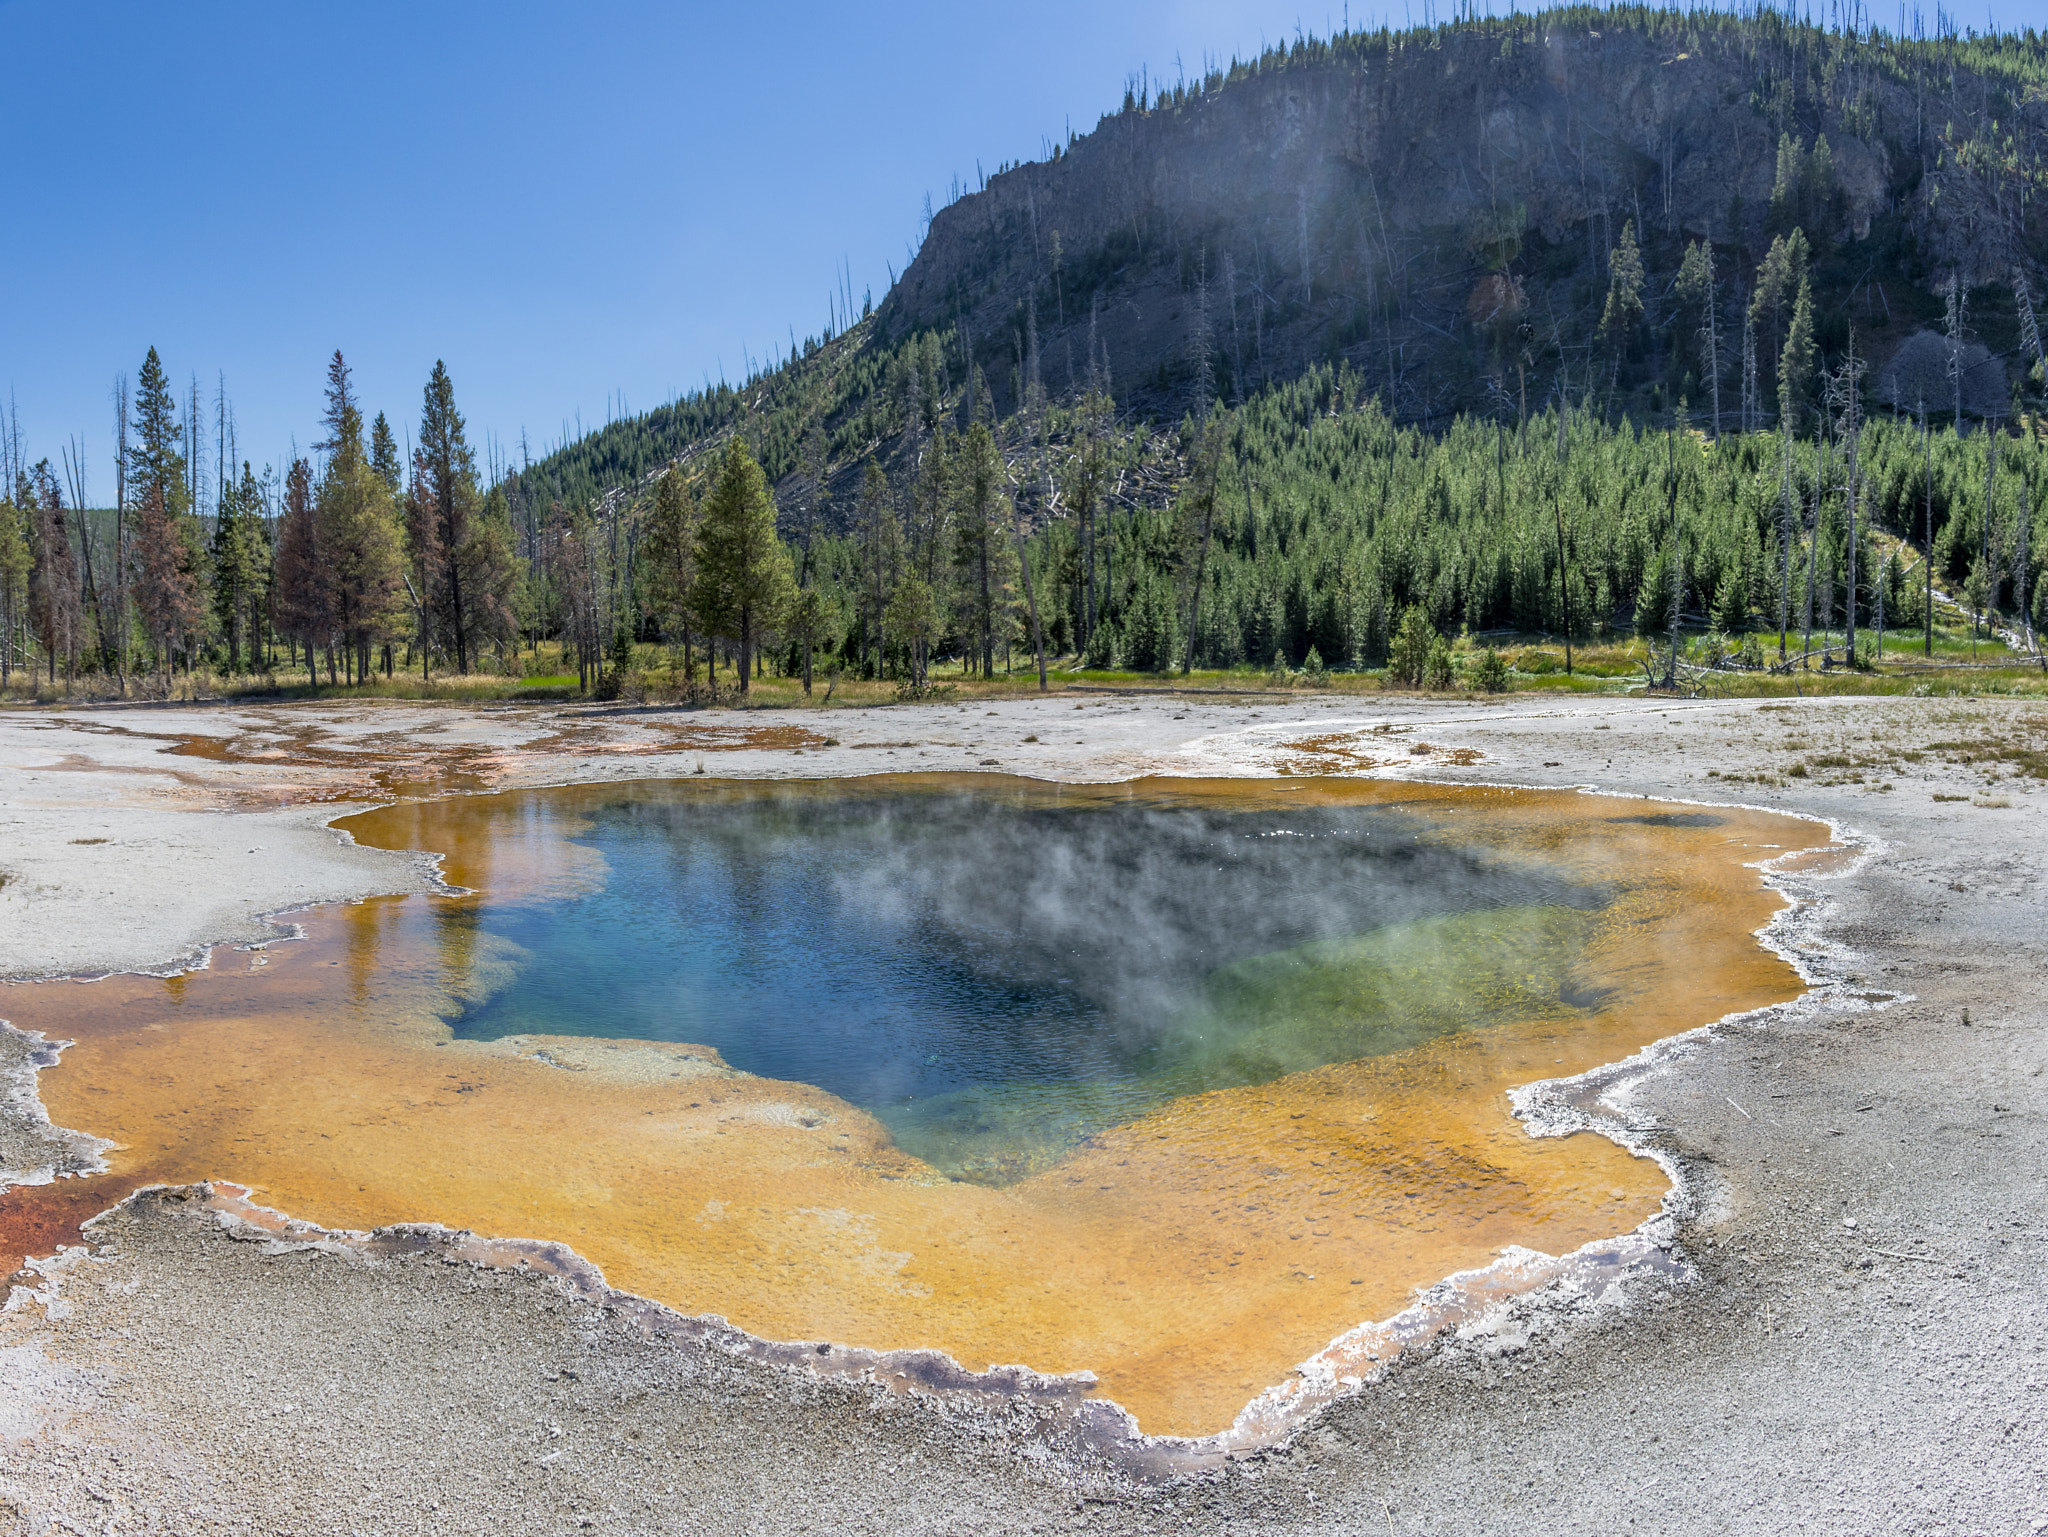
[0,6,2048,699]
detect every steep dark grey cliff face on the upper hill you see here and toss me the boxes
[881,12,2042,420]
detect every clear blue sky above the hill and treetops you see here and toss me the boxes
[0,0,2048,502]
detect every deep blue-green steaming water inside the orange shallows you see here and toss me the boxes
[451,785,1604,1182]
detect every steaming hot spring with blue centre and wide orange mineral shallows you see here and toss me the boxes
[6,777,1825,1435]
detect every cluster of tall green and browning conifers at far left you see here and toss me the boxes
[0,348,524,693]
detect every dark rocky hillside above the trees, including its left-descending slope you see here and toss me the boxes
[514,8,2048,528]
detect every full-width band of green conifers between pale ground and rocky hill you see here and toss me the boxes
[0,311,2048,704]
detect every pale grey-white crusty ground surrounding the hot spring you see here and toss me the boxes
[0,697,2048,1533]
